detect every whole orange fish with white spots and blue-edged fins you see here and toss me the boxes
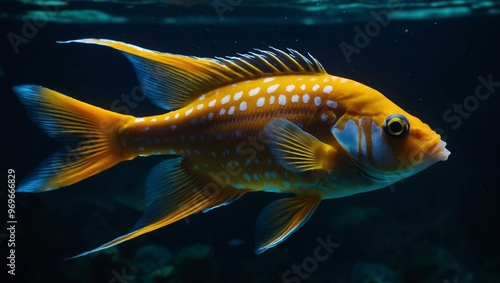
[13,38,450,258]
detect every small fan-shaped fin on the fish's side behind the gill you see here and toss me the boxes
[264,118,335,172]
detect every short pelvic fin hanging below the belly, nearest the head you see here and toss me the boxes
[255,196,321,254]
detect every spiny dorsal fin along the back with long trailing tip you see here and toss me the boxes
[60,39,325,110]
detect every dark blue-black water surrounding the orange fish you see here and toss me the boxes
[0,4,500,283]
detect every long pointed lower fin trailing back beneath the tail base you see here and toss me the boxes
[69,156,247,259]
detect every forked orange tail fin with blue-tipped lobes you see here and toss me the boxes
[14,85,134,192]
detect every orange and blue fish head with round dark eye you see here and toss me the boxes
[331,91,450,187]
